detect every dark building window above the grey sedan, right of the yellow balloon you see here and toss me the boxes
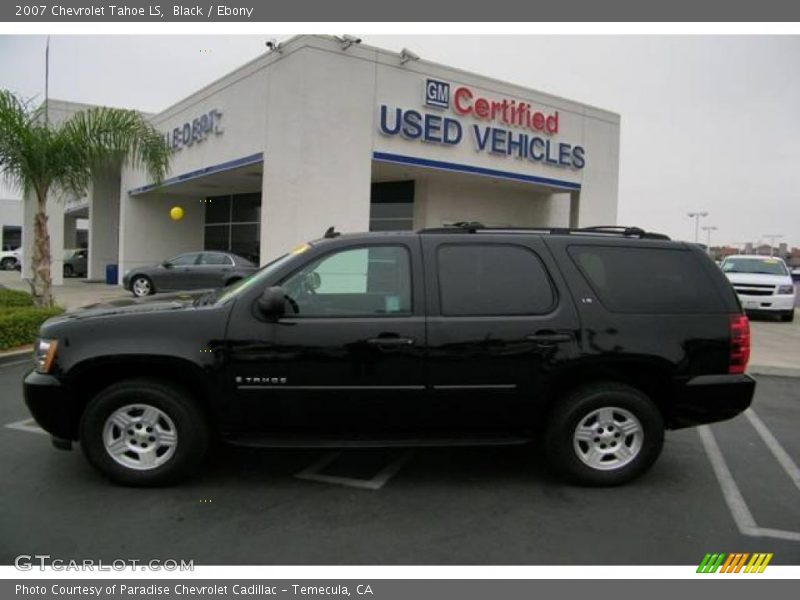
[203,193,261,264]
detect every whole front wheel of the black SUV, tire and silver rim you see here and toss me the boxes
[80,379,209,486]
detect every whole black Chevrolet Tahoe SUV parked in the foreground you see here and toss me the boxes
[24,223,755,485]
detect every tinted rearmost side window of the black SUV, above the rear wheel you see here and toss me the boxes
[568,246,724,314]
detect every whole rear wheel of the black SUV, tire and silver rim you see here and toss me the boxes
[545,382,664,486]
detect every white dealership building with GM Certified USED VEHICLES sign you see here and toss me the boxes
[18,35,620,283]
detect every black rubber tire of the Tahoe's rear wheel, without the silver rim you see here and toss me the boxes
[545,382,664,486]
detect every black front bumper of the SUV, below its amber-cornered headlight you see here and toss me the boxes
[22,371,78,440]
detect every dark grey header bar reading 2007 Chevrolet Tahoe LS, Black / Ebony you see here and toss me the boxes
[0,0,800,23]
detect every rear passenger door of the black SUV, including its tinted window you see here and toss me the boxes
[422,234,579,429]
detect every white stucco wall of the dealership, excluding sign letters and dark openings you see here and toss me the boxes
[120,36,619,272]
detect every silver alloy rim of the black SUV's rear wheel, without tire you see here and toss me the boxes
[572,406,644,471]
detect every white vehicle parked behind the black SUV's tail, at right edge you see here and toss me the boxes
[721,255,795,321]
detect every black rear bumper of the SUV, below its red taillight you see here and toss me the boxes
[668,375,756,429]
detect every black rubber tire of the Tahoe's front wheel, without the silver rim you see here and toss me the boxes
[80,378,209,486]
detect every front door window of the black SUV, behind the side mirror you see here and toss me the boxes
[282,246,411,317]
